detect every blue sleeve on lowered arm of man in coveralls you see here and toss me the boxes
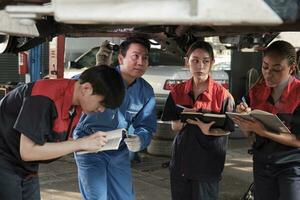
[132,95,157,149]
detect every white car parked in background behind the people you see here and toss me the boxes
[64,47,229,117]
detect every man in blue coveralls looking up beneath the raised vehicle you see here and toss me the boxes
[73,37,156,200]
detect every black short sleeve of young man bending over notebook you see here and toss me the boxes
[14,96,57,145]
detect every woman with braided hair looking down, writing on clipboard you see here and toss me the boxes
[234,41,300,200]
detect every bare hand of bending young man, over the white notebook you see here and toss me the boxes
[78,131,107,151]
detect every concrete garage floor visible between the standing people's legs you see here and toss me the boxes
[40,138,252,200]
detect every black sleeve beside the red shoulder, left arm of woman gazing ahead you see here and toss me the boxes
[161,93,181,121]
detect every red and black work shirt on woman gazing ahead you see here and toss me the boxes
[162,77,234,180]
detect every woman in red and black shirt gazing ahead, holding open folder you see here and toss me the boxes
[162,41,234,200]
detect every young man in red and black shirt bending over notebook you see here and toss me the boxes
[0,66,125,200]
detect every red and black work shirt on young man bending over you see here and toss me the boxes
[0,79,81,175]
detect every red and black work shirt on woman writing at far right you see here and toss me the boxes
[247,77,300,162]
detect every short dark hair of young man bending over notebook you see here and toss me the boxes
[79,65,125,109]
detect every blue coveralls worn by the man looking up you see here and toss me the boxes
[73,67,156,200]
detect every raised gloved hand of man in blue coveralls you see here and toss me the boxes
[96,40,113,66]
